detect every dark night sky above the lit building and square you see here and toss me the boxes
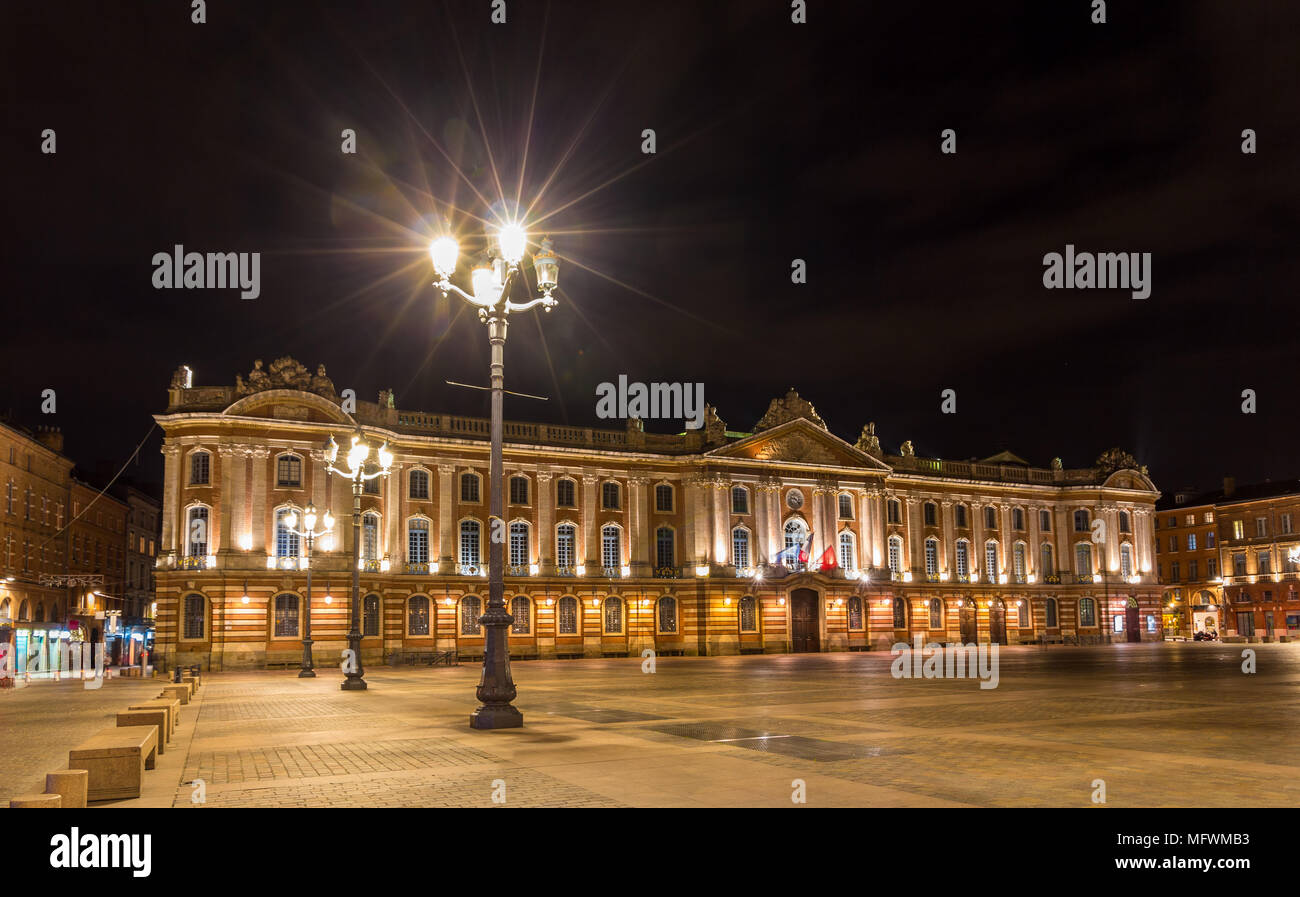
[0,0,1300,491]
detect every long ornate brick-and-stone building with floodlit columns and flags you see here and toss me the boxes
[156,359,1161,670]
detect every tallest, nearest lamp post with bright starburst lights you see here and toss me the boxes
[429,222,559,729]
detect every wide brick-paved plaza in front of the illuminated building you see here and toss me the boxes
[0,644,1300,807]
